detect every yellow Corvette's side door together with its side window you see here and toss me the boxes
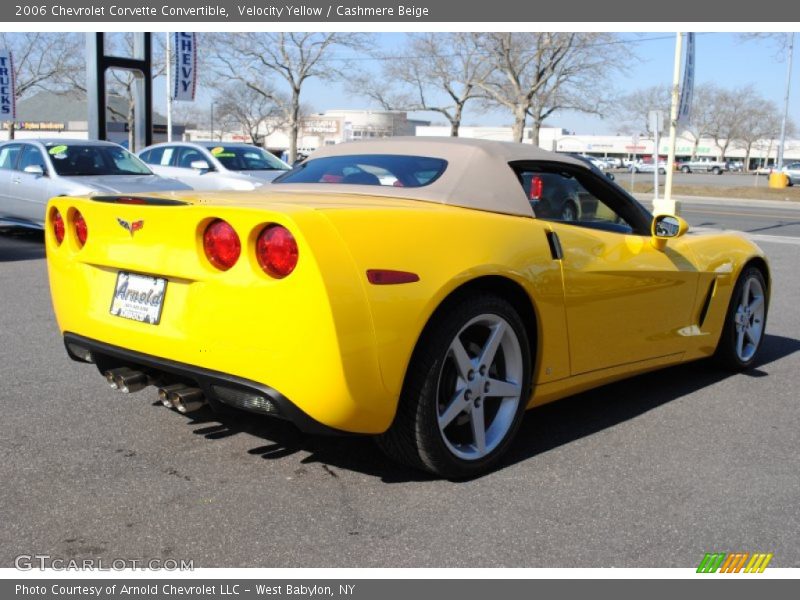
[512,161,699,375]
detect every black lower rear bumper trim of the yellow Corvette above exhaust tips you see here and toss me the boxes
[64,332,347,435]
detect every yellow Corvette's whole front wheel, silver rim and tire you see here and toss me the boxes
[715,267,768,371]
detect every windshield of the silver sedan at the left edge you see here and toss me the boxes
[46,143,153,177]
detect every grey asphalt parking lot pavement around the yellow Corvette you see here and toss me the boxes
[0,200,800,567]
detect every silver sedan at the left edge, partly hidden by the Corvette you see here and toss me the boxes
[0,139,190,229]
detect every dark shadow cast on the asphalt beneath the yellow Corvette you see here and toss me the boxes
[172,335,800,483]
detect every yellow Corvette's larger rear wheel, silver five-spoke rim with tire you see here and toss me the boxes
[378,295,531,479]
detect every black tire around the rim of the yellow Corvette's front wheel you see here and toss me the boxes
[714,266,769,371]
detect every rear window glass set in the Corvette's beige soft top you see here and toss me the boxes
[272,154,447,187]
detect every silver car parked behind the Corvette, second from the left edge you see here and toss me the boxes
[139,142,291,191]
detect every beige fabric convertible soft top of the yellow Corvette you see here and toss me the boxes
[273,137,588,217]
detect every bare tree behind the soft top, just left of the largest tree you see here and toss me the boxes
[356,33,490,137]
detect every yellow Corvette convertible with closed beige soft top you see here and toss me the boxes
[46,138,770,478]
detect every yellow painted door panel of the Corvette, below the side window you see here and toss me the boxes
[552,223,699,375]
